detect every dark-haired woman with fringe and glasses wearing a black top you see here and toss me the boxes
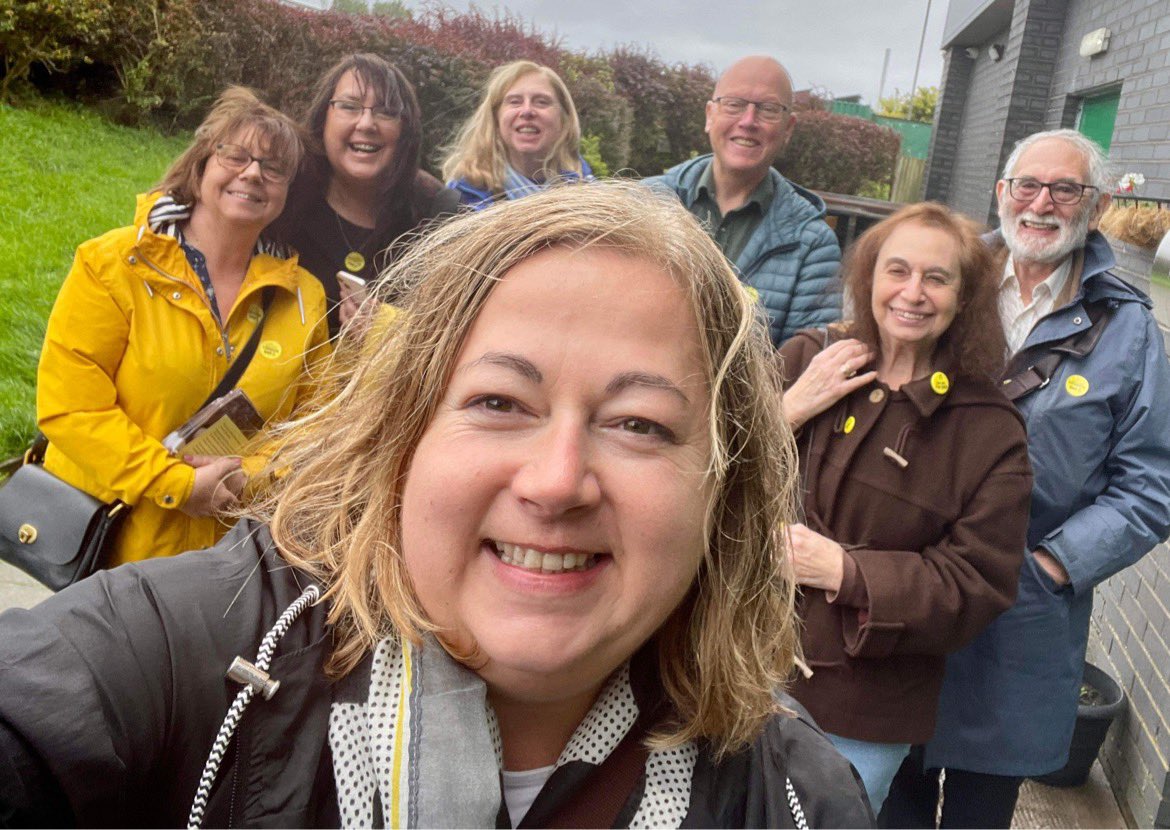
[274,54,459,335]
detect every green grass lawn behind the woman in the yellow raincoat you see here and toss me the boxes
[0,103,190,459]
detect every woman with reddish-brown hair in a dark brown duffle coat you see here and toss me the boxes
[780,204,1031,810]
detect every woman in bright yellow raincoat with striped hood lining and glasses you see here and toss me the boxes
[36,87,328,565]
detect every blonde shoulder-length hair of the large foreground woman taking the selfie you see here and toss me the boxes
[252,181,798,753]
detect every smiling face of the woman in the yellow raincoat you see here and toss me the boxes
[194,130,289,233]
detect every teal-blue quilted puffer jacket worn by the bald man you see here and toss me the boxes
[645,153,841,347]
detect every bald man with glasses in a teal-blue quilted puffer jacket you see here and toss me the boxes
[646,56,841,345]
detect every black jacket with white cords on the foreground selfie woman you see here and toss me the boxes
[0,522,872,826]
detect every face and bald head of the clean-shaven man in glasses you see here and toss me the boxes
[704,57,796,181]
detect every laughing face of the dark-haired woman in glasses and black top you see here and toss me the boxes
[322,70,401,187]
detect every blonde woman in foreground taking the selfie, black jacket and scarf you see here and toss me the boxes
[0,184,872,826]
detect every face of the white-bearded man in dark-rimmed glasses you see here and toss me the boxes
[996,138,1108,263]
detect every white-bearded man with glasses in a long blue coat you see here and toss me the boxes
[882,130,1170,828]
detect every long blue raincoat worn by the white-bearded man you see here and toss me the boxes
[925,232,1170,776]
